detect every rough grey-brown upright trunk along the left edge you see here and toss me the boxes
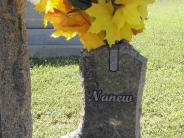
[0,0,32,138]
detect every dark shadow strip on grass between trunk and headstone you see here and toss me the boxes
[30,56,79,68]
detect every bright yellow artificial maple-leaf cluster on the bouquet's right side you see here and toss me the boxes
[86,0,153,46]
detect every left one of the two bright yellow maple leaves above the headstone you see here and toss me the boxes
[86,0,120,46]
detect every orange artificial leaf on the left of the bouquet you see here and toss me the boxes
[45,10,90,40]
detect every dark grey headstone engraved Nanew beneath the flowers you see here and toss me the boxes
[63,42,147,138]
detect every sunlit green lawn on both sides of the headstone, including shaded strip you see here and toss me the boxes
[31,0,184,138]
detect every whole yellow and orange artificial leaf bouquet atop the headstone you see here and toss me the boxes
[35,0,155,51]
